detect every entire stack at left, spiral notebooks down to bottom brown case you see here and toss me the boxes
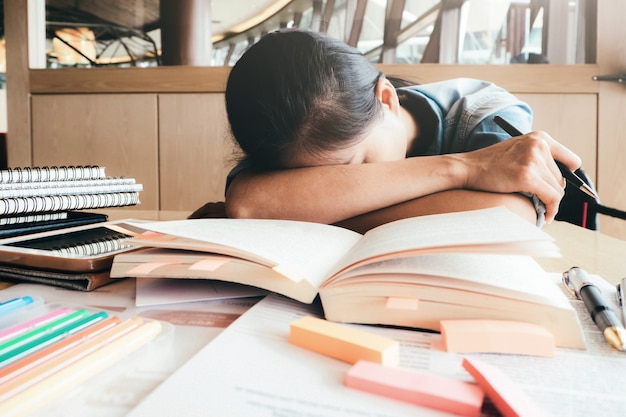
[0,165,142,290]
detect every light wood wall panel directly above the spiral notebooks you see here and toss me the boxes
[31,94,159,210]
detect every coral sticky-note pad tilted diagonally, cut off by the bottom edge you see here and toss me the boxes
[463,358,546,417]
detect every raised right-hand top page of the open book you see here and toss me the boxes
[335,207,560,273]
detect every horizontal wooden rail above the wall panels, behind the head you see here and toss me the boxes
[29,64,598,94]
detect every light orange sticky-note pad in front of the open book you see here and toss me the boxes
[289,316,400,366]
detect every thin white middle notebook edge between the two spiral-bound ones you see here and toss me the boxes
[0,182,143,199]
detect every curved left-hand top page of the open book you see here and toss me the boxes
[125,219,361,288]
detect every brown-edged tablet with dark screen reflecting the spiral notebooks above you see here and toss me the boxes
[0,221,135,272]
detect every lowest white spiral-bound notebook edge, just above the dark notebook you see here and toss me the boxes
[0,192,139,216]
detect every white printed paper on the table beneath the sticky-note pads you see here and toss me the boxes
[129,295,626,417]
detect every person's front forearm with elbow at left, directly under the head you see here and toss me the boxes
[226,155,465,223]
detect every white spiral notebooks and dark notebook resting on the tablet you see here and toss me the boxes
[0,165,142,238]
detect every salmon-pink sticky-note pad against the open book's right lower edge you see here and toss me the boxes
[440,320,555,357]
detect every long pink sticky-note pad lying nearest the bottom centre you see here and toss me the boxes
[345,361,485,417]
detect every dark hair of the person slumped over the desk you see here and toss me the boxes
[226,29,382,170]
